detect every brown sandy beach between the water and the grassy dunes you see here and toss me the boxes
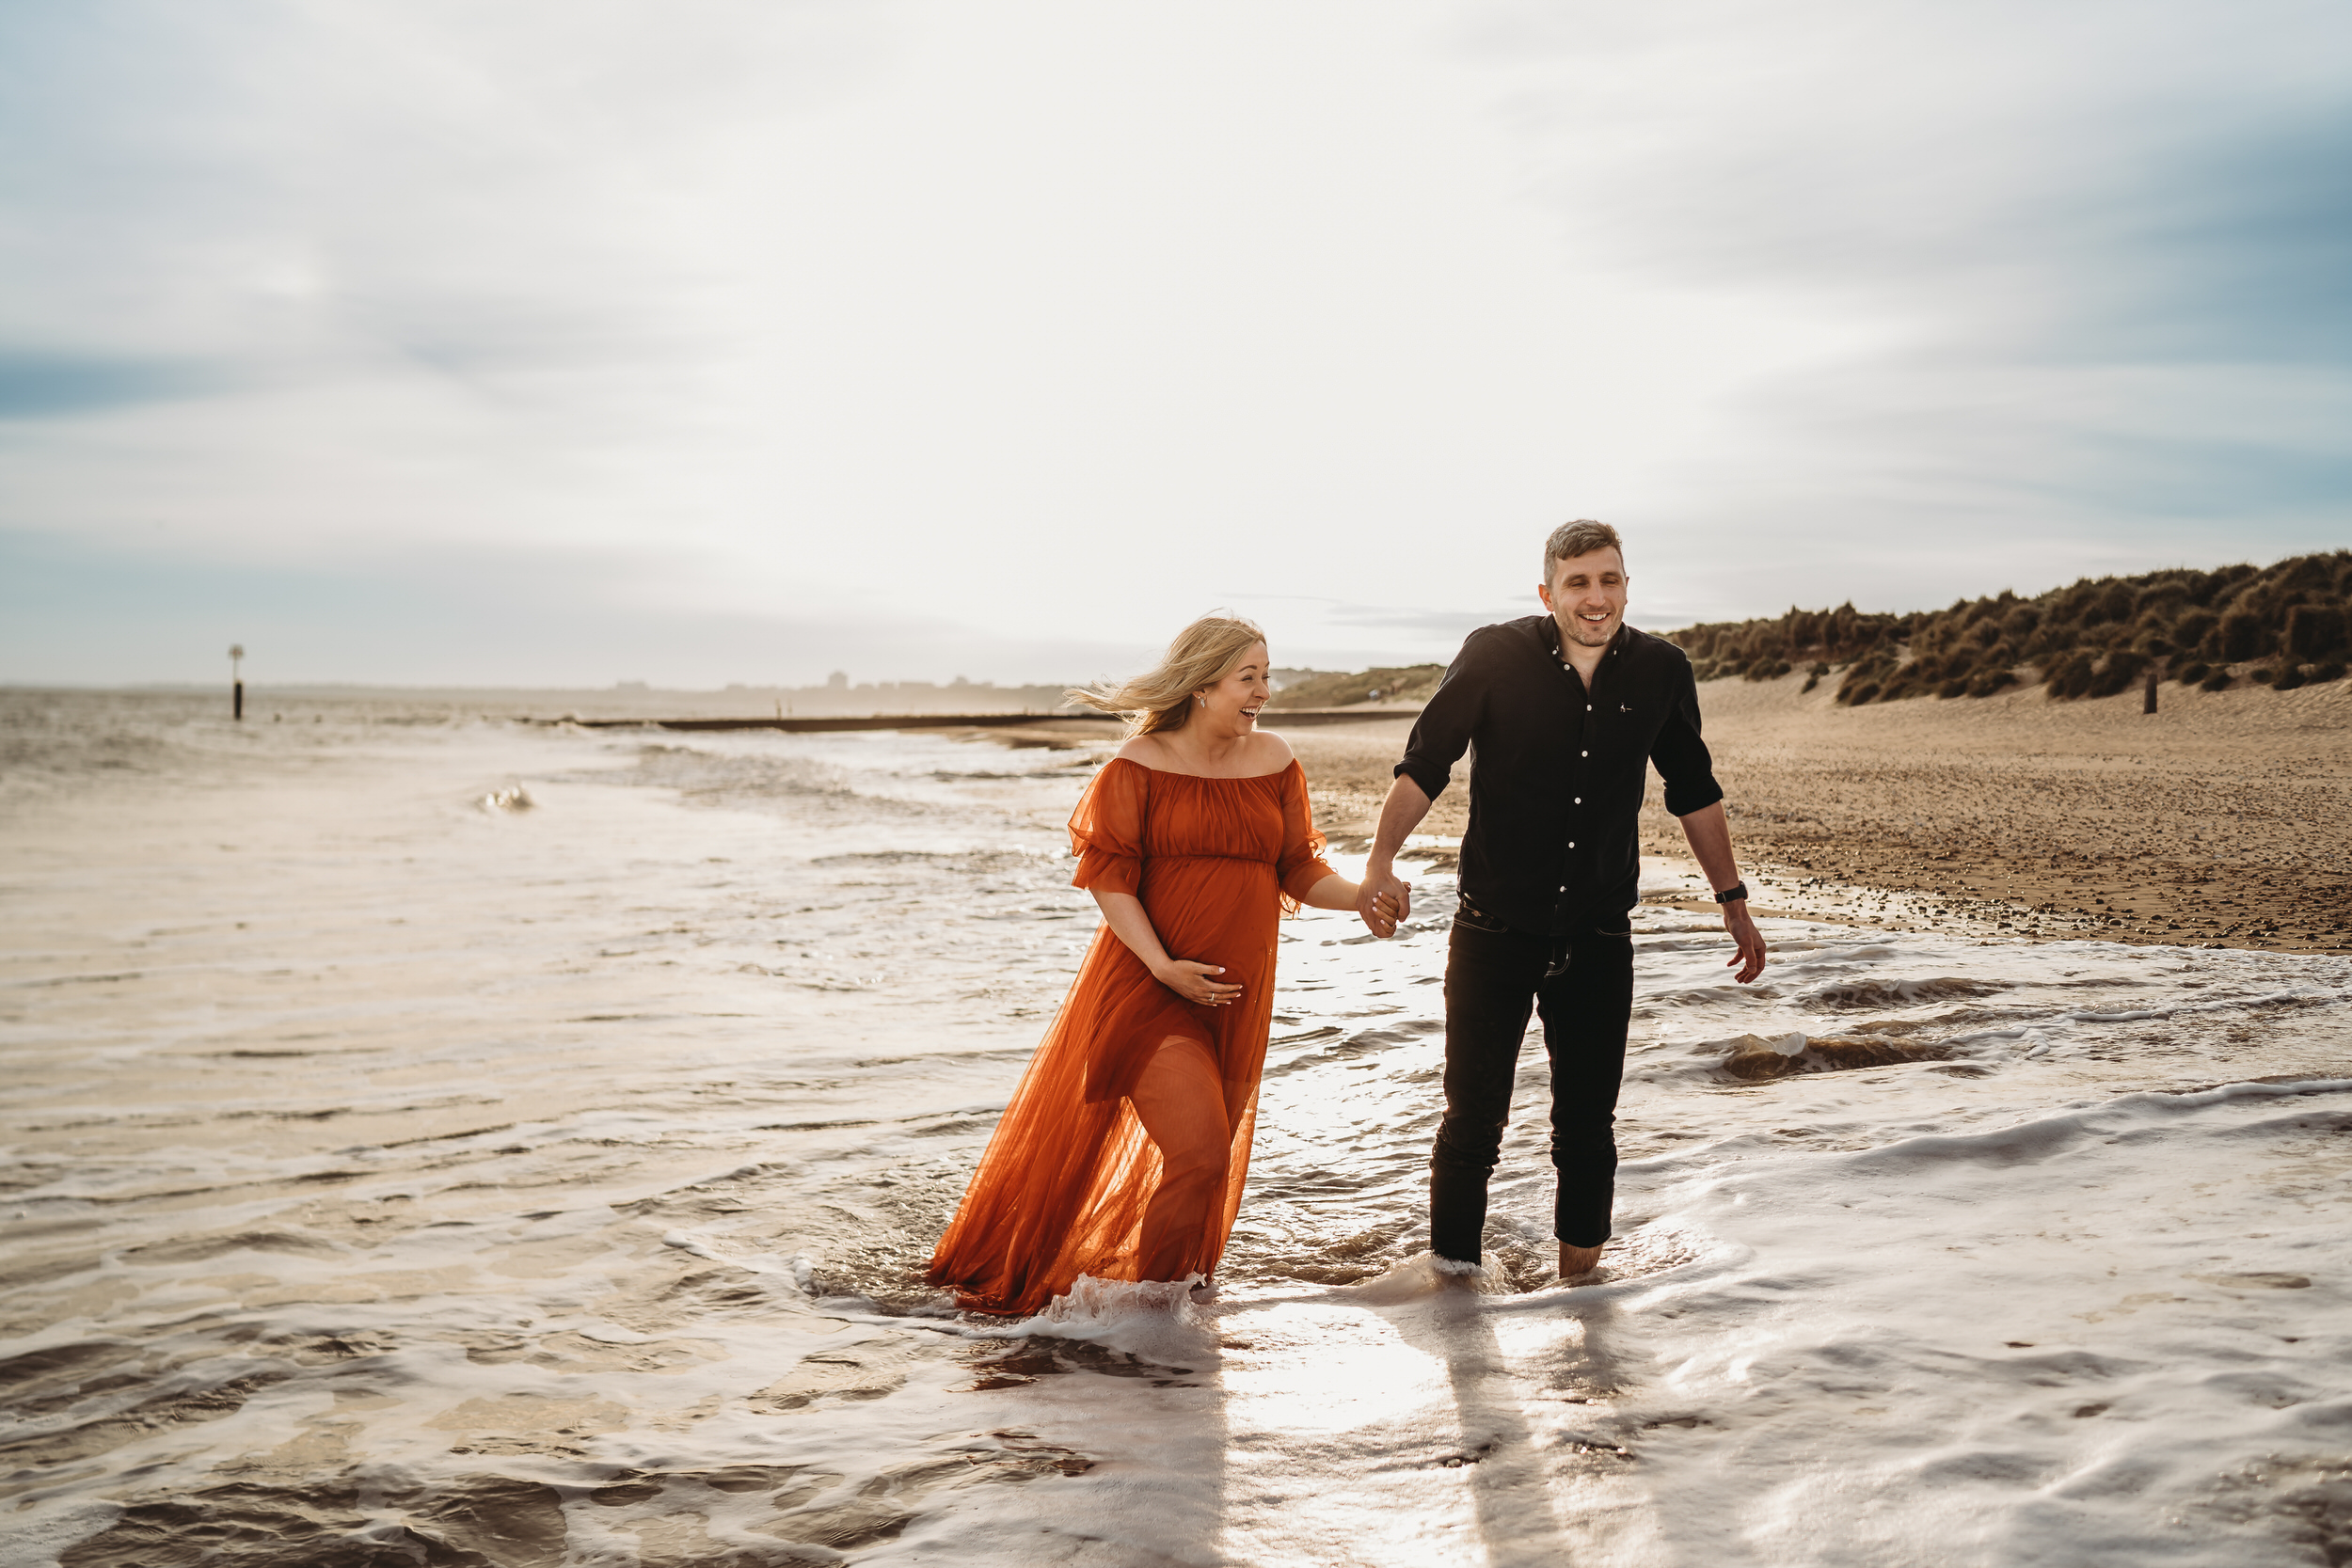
[1275,674,2352,952]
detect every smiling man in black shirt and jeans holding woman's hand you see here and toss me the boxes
[1358,522,1764,1279]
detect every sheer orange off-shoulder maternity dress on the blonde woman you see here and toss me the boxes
[930,757,1331,1314]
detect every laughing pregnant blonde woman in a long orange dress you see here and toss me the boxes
[930,616,1395,1314]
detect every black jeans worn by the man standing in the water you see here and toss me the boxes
[1430,905,1632,1262]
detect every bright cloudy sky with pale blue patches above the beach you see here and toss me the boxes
[0,0,2352,687]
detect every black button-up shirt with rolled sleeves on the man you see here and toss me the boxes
[1397,616,1724,933]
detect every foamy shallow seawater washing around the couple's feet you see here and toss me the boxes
[13,696,2352,1568]
